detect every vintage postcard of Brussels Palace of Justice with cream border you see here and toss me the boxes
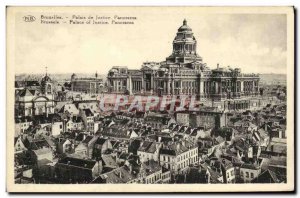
[6,6,295,193]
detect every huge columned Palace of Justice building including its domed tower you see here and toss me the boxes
[107,20,259,101]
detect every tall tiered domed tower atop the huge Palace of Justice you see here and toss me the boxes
[166,19,202,63]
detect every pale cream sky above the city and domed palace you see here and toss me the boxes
[15,8,287,74]
